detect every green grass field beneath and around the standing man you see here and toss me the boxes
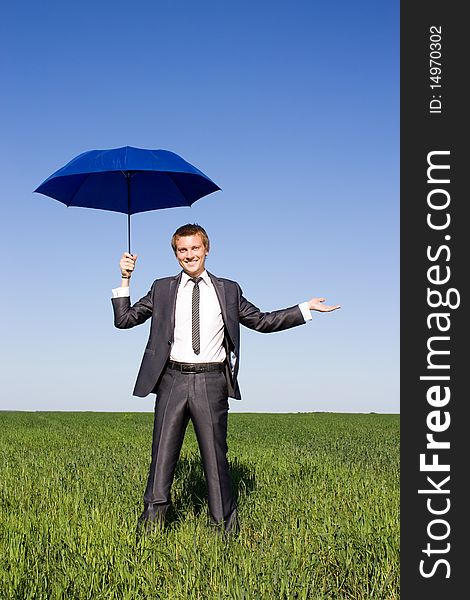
[0,412,399,600]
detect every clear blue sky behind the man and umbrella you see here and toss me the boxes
[0,0,399,412]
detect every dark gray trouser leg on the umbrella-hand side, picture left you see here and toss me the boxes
[144,369,189,520]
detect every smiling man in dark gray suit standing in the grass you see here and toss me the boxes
[112,224,339,532]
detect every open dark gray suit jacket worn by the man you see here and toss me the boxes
[112,273,305,400]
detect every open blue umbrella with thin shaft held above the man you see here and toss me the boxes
[34,146,220,253]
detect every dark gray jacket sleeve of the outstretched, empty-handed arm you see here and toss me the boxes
[239,290,305,333]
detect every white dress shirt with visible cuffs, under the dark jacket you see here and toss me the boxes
[113,271,312,363]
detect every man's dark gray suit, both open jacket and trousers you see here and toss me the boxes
[112,273,305,529]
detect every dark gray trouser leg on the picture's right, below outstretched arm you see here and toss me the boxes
[188,373,236,531]
